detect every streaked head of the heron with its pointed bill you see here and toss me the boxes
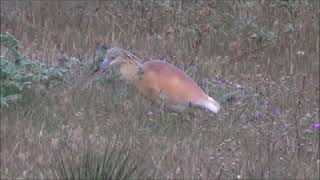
[95,47,139,73]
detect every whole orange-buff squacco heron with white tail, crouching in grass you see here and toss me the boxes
[96,47,220,113]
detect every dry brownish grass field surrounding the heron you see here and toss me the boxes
[1,0,320,179]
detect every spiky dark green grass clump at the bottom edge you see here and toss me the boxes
[52,139,147,180]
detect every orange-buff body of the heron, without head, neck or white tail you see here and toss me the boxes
[135,60,207,110]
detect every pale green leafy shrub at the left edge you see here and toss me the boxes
[0,33,74,107]
